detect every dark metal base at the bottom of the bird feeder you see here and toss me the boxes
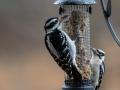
[62,79,94,90]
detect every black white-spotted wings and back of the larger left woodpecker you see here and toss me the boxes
[45,30,72,77]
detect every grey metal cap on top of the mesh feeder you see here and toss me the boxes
[54,0,96,5]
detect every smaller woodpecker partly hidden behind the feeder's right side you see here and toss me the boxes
[90,48,105,90]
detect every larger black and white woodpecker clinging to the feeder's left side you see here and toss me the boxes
[44,15,81,81]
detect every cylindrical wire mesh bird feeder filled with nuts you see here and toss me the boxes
[54,0,96,90]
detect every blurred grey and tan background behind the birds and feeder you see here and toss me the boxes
[0,0,120,90]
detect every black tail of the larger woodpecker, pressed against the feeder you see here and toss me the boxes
[72,65,82,83]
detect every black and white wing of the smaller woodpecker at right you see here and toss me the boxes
[95,62,105,90]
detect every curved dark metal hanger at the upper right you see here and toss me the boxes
[100,0,120,46]
